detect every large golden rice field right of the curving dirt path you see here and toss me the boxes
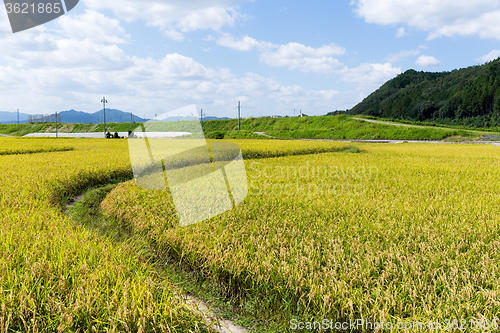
[102,142,500,331]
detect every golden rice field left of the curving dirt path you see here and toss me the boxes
[0,138,219,332]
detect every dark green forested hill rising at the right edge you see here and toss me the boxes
[349,58,500,126]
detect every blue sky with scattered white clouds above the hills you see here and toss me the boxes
[0,0,500,117]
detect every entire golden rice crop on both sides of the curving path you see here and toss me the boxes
[0,138,500,332]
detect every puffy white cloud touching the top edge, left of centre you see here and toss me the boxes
[85,0,251,40]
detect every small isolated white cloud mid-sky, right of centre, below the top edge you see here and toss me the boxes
[260,43,345,74]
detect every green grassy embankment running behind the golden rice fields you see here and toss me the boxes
[0,115,488,140]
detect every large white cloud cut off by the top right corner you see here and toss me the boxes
[351,0,500,39]
